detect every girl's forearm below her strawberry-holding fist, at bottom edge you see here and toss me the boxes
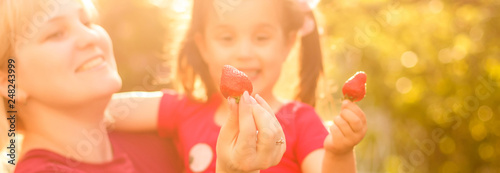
[322,150,356,173]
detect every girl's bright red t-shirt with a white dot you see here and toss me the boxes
[158,90,328,173]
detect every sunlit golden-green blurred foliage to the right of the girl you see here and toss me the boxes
[319,0,500,172]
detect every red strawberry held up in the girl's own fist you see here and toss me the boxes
[342,71,366,102]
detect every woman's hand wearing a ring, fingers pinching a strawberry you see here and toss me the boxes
[216,92,286,172]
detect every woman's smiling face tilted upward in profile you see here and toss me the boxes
[15,0,121,106]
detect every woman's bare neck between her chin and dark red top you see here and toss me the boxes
[21,98,113,163]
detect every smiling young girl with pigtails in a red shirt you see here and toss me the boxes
[111,0,366,173]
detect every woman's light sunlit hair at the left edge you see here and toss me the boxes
[0,0,97,150]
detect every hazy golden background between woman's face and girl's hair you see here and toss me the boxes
[98,0,177,91]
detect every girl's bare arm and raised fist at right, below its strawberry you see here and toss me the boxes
[301,101,367,173]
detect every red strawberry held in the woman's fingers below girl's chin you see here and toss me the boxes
[220,65,253,103]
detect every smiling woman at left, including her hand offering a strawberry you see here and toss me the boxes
[0,0,285,173]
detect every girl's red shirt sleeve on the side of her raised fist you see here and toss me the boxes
[295,103,328,165]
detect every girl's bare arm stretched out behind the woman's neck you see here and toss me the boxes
[107,91,163,132]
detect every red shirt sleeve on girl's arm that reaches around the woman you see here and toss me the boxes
[158,90,185,137]
